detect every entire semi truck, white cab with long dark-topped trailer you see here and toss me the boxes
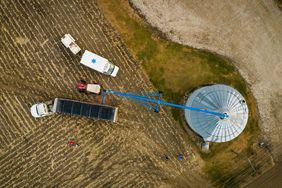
[30,98,118,122]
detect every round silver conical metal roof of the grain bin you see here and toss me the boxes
[185,85,248,142]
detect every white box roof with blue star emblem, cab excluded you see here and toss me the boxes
[80,50,109,73]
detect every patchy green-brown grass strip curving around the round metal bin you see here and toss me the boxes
[99,0,259,185]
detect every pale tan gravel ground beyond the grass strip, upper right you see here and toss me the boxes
[130,0,282,159]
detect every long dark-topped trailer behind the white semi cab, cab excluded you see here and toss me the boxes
[54,98,118,122]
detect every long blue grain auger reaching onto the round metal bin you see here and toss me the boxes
[102,90,228,119]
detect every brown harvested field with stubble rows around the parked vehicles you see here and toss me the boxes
[0,0,214,187]
